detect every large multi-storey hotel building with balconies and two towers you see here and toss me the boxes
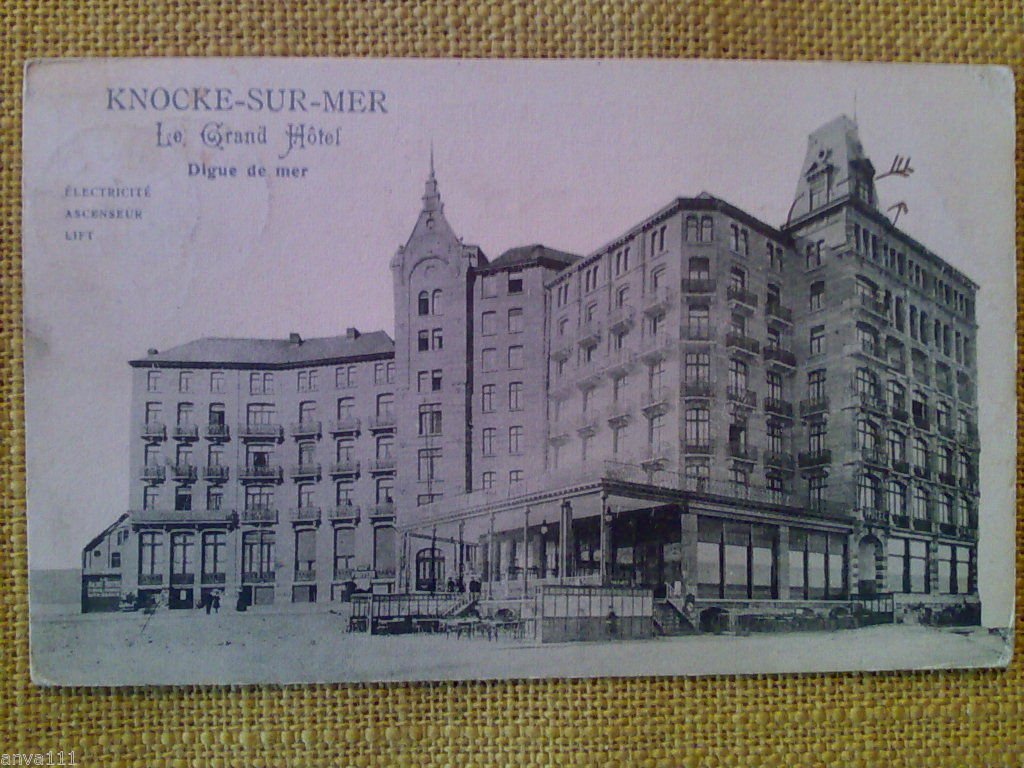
[83,117,979,622]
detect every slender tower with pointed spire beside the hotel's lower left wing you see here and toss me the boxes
[391,156,486,525]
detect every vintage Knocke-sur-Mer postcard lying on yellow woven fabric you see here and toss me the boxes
[24,59,1016,685]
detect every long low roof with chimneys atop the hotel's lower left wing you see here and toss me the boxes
[130,331,394,368]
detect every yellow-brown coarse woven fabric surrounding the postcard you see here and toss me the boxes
[0,0,1024,768]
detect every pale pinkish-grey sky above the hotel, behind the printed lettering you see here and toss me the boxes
[24,59,1016,623]
